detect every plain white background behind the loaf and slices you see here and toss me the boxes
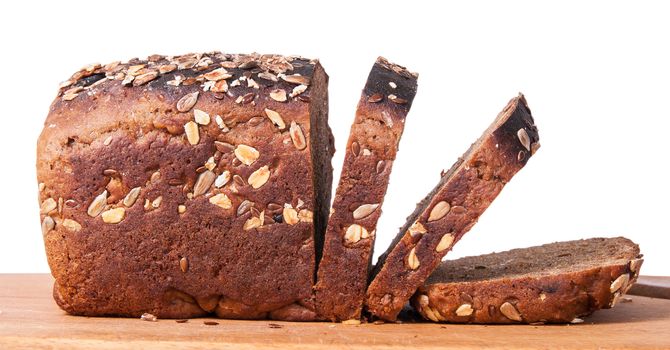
[0,1,670,275]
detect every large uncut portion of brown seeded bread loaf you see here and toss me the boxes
[37,52,334,320]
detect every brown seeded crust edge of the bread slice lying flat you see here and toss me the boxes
[412,237,642,324]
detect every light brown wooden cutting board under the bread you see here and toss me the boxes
[0,274,670,350]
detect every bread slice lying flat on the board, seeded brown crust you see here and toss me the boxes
[412,237,642,323]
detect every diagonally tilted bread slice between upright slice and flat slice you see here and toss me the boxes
[366,94,539,321]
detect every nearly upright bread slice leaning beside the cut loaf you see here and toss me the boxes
[315,57,417,321]
